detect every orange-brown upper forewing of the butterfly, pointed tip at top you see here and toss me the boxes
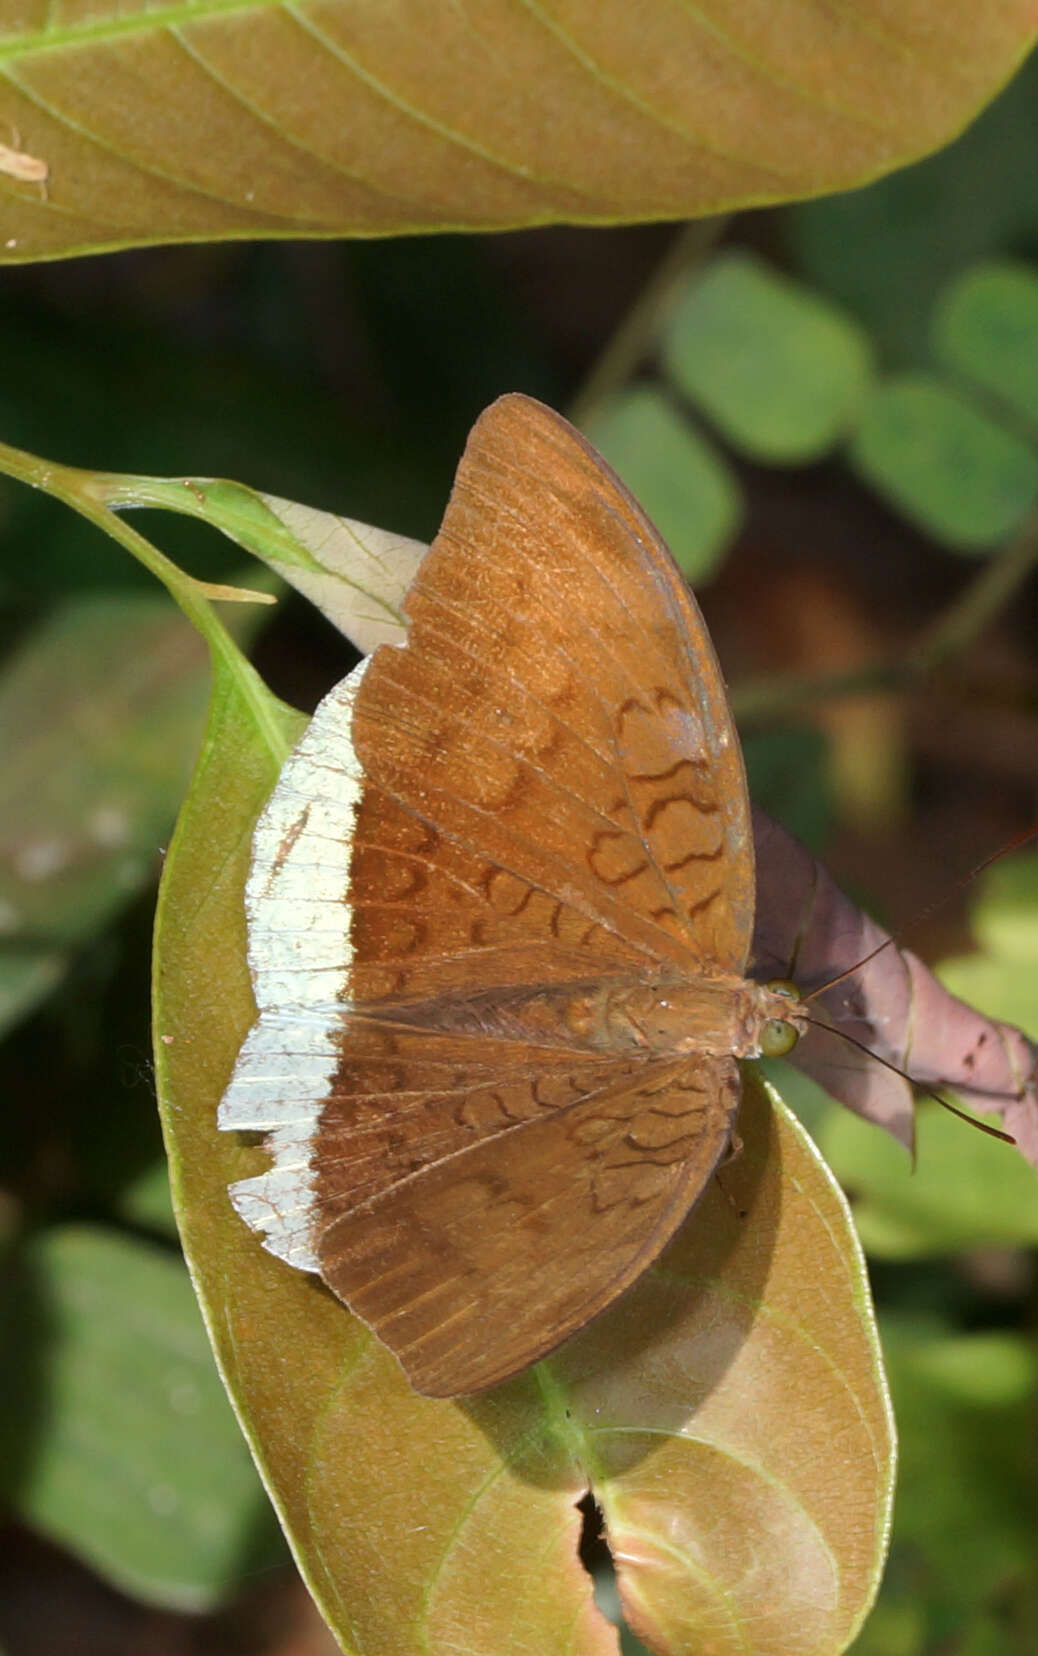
[382,397,753,970]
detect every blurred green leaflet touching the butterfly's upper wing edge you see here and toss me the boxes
[584,386,742,583]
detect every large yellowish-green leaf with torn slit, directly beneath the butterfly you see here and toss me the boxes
[156,661,892,1656]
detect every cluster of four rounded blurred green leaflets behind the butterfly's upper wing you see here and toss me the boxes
[572,241,1038,563]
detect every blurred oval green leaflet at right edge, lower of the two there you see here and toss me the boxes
[851,374,1038,551]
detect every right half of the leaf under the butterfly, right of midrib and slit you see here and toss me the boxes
[589,1083,892,1656]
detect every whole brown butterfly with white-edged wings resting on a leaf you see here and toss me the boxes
[220,396,803,1396]
